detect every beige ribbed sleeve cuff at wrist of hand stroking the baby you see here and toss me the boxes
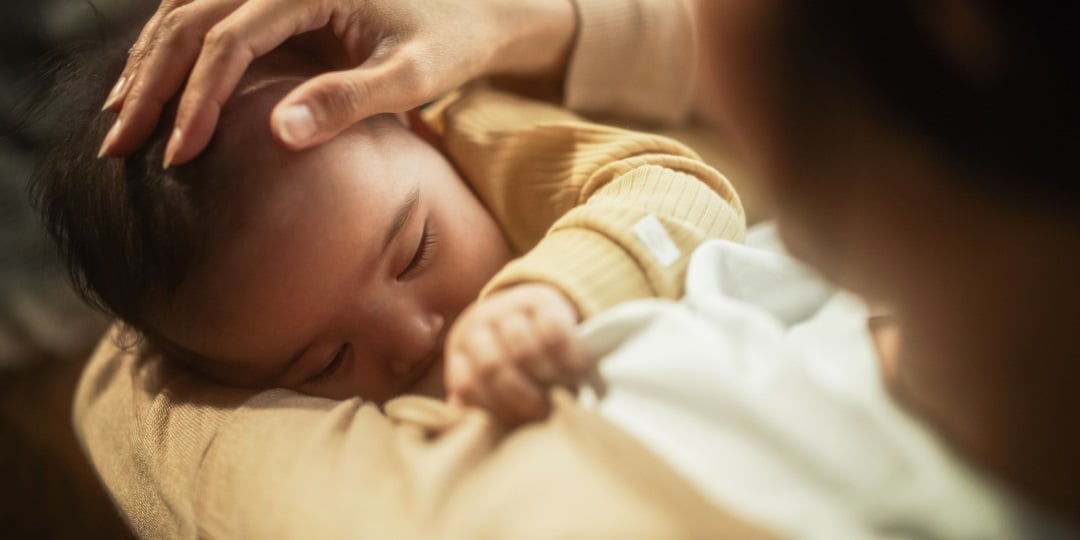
[564,0,698,124]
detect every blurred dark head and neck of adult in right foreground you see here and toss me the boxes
[699,0,1080,515]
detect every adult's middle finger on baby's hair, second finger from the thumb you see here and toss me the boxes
[102,0,241,156]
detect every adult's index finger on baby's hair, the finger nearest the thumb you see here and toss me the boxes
[165,0,330,167]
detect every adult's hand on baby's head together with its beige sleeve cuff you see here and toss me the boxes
[102,0,697,163]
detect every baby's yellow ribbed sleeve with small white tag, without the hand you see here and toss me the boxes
[444,89,745,319]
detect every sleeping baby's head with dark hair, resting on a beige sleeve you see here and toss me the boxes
[36,39,511,402]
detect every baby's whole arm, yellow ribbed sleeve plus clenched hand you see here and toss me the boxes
[436,91,745,420]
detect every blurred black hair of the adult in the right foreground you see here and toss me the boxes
[784,0,1080,206]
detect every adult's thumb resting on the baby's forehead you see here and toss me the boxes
[270,63,424,149]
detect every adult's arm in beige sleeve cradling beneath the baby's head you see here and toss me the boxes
[75,326,764,539]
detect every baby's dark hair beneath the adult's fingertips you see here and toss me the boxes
[30,33,223,335]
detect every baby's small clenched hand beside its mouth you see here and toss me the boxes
[446,283,588,423]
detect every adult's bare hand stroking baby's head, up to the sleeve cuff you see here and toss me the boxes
[102,0,576,166]
